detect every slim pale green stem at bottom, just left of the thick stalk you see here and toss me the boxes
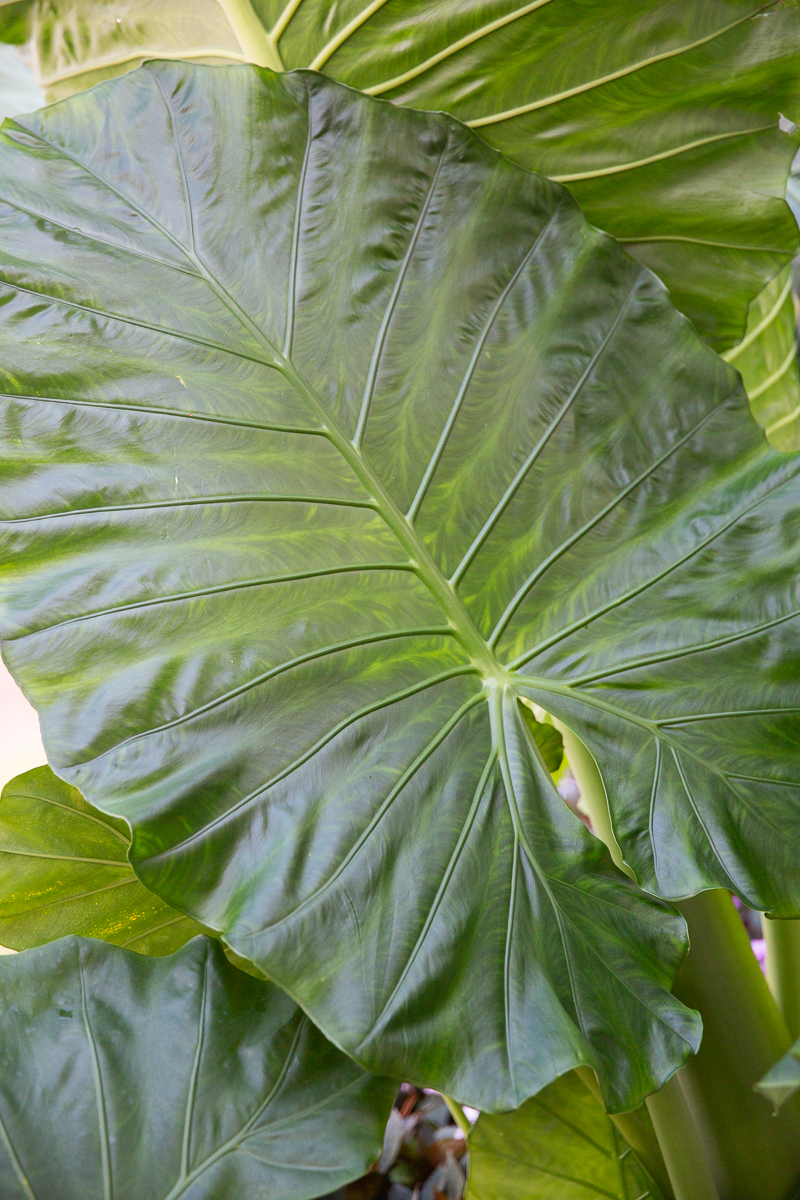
[645,1075,720,1200]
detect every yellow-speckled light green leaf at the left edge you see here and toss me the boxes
[0,767,204,955]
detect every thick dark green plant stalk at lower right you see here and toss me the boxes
[676,889,800,1200]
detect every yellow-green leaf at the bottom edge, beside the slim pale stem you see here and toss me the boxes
[467,1072,662,1200]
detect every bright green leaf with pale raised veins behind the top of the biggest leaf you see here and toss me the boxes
[0,0,800,349]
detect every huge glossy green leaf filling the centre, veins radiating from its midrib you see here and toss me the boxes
[9,64,800,1110]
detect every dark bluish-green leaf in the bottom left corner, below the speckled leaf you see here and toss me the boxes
[0,937,395,1200]
